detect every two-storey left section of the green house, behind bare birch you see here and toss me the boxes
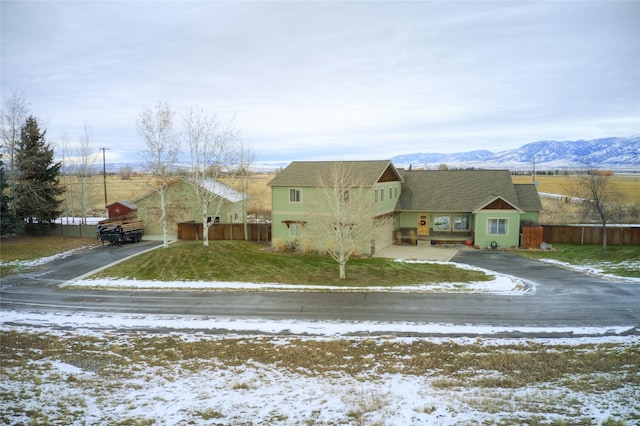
[269,160,402,253]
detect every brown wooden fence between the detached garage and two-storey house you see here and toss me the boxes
[178,222,271,241]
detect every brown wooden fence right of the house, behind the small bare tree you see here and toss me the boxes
[542,225,640,246]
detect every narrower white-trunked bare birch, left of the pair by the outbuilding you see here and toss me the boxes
[136,102,180,248]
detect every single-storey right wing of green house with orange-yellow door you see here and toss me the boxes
[394,170,542,247]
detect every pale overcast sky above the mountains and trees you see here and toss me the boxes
[1,0,640,162]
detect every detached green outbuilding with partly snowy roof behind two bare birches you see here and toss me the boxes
[135,178,244,237]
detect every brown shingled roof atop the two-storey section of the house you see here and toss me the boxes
[269,160,402,187]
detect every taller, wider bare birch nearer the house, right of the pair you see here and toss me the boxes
[183,106,246,246]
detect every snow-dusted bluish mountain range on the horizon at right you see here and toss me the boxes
[391,135,640,172]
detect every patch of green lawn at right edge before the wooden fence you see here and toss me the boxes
[514,244,640,278]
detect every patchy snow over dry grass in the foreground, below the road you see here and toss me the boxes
[0,320,640,425]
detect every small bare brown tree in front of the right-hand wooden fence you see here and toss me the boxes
[577,169,622,256]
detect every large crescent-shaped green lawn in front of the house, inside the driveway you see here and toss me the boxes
[94,241,492,286]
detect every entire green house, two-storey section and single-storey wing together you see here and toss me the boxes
[269,160,542,253]
